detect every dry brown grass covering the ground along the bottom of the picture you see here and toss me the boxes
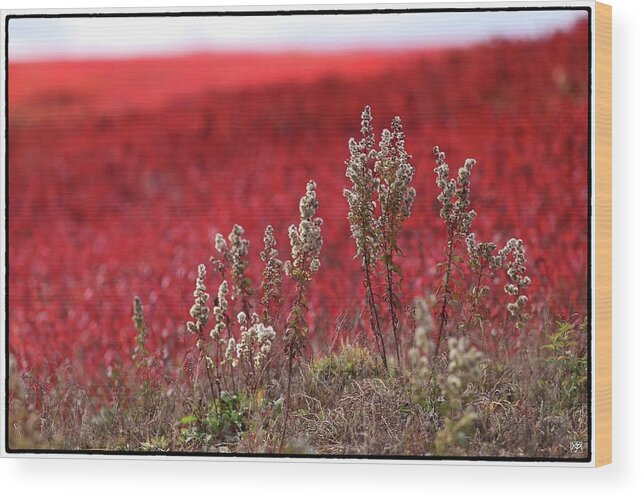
[9,322,588,458]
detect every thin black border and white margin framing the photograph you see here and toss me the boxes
[3,5,595,464]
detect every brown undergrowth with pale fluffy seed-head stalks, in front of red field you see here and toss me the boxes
[9,107,589,458]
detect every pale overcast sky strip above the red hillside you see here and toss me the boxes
[9,10,587,61]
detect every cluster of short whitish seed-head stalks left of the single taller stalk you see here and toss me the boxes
[187,225,281,403]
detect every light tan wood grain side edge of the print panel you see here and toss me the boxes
[594,2,612,466]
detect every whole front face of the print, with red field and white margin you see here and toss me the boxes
[2,2,595,465]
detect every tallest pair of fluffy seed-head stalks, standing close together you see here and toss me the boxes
[344,106,415,368]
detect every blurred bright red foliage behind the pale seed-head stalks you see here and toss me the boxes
[8,21,588,388]
